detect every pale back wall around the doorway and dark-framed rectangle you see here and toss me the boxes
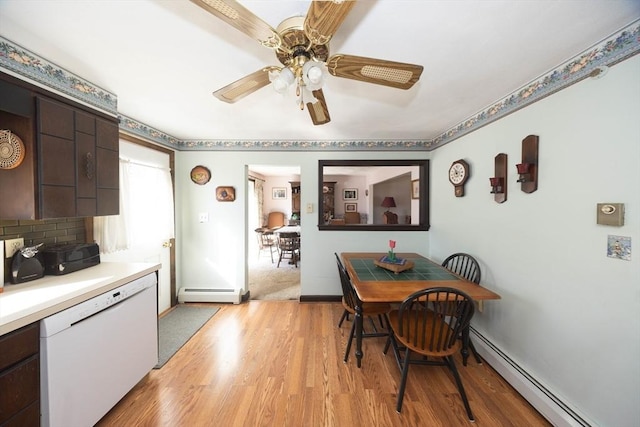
[175,151,429,296]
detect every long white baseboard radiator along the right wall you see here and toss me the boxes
[469,327,595,427]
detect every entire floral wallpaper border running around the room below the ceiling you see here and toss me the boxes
[0,20,640,151]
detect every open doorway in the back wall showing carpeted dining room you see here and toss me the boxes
[246,165,303,300]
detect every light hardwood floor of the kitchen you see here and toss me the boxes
[98,301,550,427]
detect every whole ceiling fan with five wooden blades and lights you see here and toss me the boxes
[191,0,423,125]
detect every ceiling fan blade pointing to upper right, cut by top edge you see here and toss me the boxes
[304,0,356,45]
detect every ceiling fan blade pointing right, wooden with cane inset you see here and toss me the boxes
[327,54,424,89]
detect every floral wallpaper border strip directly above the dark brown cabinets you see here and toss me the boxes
[0,36,118,116]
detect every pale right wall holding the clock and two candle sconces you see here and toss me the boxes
[429,56,640,427]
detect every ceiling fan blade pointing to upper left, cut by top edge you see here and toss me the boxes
[191,0,282,49]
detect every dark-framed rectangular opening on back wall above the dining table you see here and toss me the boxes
[318,159,429,231]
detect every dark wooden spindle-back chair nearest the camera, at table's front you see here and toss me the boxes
[389,287,474,421]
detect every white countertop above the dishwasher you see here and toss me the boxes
[0,262,160,335]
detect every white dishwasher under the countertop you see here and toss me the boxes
[40,273,158,427]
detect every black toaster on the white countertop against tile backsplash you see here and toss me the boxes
[41,243,100,276]
